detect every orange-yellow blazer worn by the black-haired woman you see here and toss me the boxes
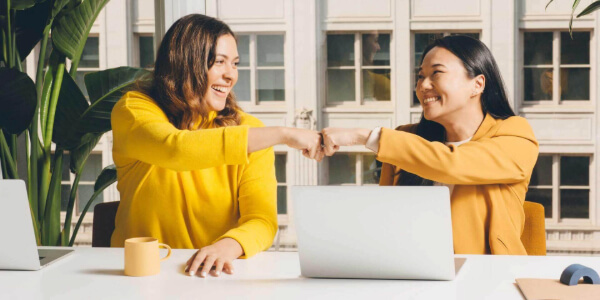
[377,114,539,255]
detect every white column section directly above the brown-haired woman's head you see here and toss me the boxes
[154,0,206,48]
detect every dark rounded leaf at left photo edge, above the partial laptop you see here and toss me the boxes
[0,67,37,134]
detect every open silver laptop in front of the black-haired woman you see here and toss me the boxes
[291,186,455,280]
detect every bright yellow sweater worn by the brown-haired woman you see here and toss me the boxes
[111,92,277,257]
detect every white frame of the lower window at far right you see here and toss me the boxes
[525,153,596,228]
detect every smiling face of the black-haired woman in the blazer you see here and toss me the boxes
[416,47,485,125]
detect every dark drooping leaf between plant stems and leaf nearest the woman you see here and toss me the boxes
[52,74,89,150]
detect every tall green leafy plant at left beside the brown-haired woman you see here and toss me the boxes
[0,0,149,246]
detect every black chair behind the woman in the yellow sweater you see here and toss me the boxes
[92,201,119,247]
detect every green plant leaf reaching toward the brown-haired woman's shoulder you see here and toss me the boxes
[81,67,150,133]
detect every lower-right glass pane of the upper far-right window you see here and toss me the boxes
[560,68,590,100]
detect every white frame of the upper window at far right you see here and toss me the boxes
[517,28,596,111]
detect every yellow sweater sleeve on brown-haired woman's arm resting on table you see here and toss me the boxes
[218,143,278,258]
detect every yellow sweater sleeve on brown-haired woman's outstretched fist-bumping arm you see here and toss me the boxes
[111,100,249,172]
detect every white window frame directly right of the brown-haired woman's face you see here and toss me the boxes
[236,31,290,112]
